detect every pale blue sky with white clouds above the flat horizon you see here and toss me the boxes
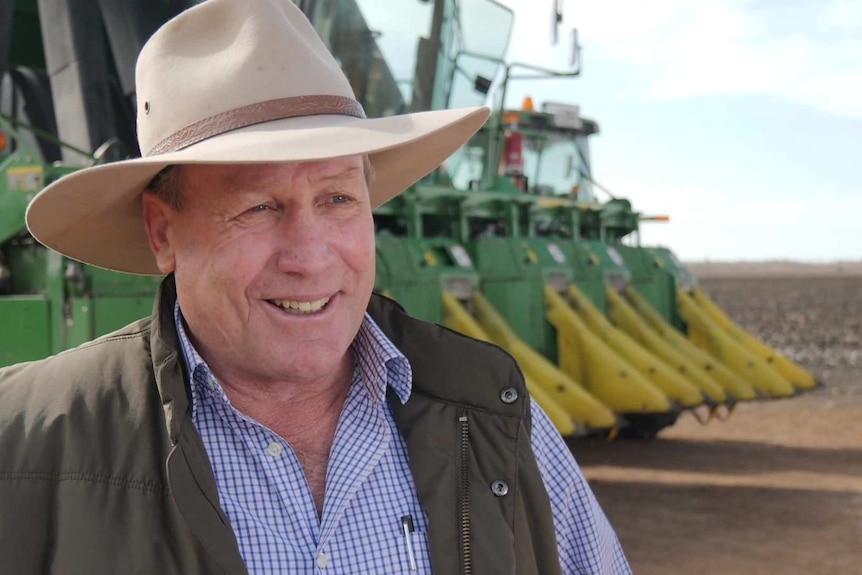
[502,0,862,262]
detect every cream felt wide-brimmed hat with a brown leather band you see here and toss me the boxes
[27,0,488,275]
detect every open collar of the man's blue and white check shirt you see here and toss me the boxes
[174,300,413,417]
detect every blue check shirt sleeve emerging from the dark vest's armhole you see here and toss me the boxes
[532,401,631,575]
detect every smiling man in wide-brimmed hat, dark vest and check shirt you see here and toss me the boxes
[0,0,628,575]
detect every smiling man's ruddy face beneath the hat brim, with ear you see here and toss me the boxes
[144,156,375,384]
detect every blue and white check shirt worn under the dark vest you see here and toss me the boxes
[174,305,631,575]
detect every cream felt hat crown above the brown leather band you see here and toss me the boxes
[135,0,355,156]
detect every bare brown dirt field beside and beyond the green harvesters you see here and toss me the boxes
[572,274,862,575]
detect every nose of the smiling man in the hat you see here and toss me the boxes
[276,209,332,275]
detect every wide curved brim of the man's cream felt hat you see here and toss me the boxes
[26,107,489,275]
